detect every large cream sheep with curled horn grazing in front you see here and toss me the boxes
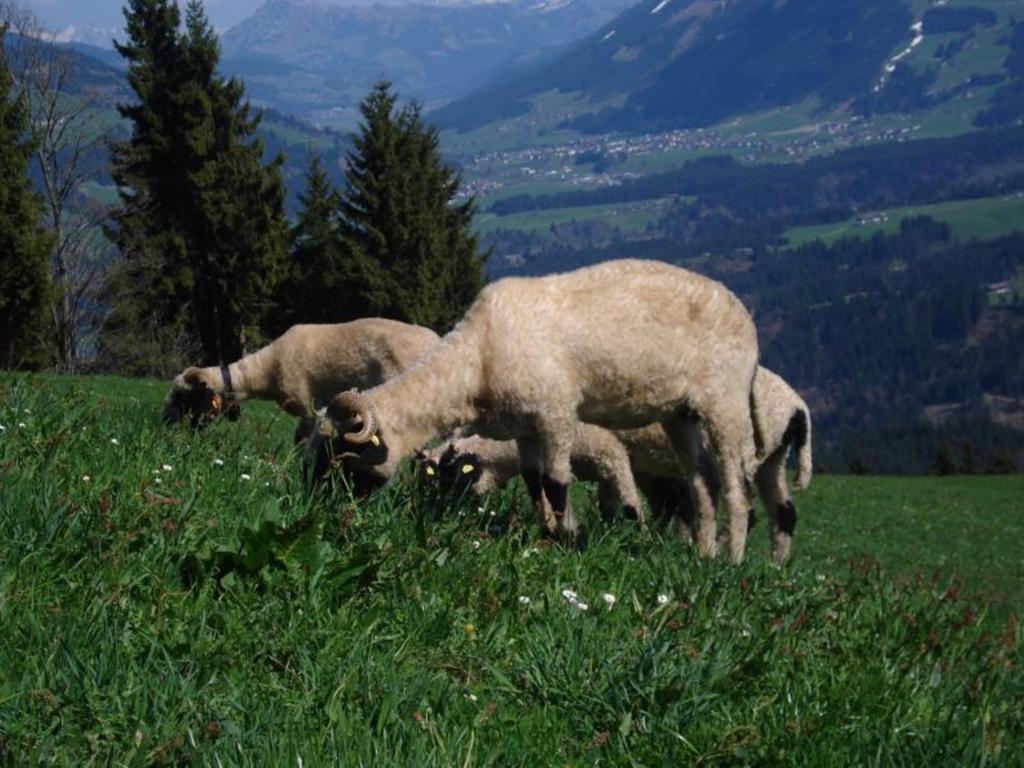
[307,259,758,563]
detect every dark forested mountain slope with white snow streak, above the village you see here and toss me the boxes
[432,0,1024,132]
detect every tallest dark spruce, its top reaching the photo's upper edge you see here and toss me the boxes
[103,0,287,364]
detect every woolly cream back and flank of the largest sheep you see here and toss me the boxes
[469,260,757,426]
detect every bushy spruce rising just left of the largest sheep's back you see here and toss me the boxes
[341,82,483,331]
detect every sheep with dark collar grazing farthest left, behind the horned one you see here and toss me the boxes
[164,317,438,442]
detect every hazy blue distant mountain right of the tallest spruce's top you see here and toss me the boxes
[221,0,630,127]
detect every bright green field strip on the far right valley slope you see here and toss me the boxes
[785,196,1024,246]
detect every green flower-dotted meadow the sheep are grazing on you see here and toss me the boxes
[0,375,1024,766]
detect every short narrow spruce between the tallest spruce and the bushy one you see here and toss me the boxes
[273,155,353,334]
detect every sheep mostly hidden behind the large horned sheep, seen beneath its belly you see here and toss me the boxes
[417,368,812,564]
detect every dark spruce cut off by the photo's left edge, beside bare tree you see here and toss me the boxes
[0,38,51,369]
